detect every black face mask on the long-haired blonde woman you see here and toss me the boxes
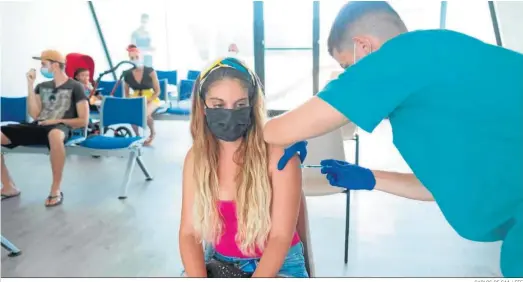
[205,107,252,142]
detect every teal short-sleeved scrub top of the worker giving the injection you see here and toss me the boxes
[318,30,523,241]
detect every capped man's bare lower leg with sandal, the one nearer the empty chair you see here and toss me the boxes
[45,128,66,206]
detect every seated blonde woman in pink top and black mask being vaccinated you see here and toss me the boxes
[179,58,308,277]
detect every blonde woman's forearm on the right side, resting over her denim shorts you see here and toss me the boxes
[252,236,292,278]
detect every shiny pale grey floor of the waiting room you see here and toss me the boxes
[1,121,500,277]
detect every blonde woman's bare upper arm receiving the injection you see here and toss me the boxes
[269,147,301,239]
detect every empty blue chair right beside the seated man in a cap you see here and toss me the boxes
[80,96,153,199]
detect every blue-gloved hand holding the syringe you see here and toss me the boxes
[320,160,376,190]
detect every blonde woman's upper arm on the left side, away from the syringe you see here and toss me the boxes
[180,148,194,238]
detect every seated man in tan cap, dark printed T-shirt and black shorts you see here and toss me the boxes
[1,50,89,207]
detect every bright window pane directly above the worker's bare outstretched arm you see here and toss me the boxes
[263,1,313,110]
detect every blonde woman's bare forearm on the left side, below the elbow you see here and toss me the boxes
[180,234,207,278]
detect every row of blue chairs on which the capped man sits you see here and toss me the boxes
[0,96,152,199]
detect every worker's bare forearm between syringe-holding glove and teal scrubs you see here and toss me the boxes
[372,170,434,201]
